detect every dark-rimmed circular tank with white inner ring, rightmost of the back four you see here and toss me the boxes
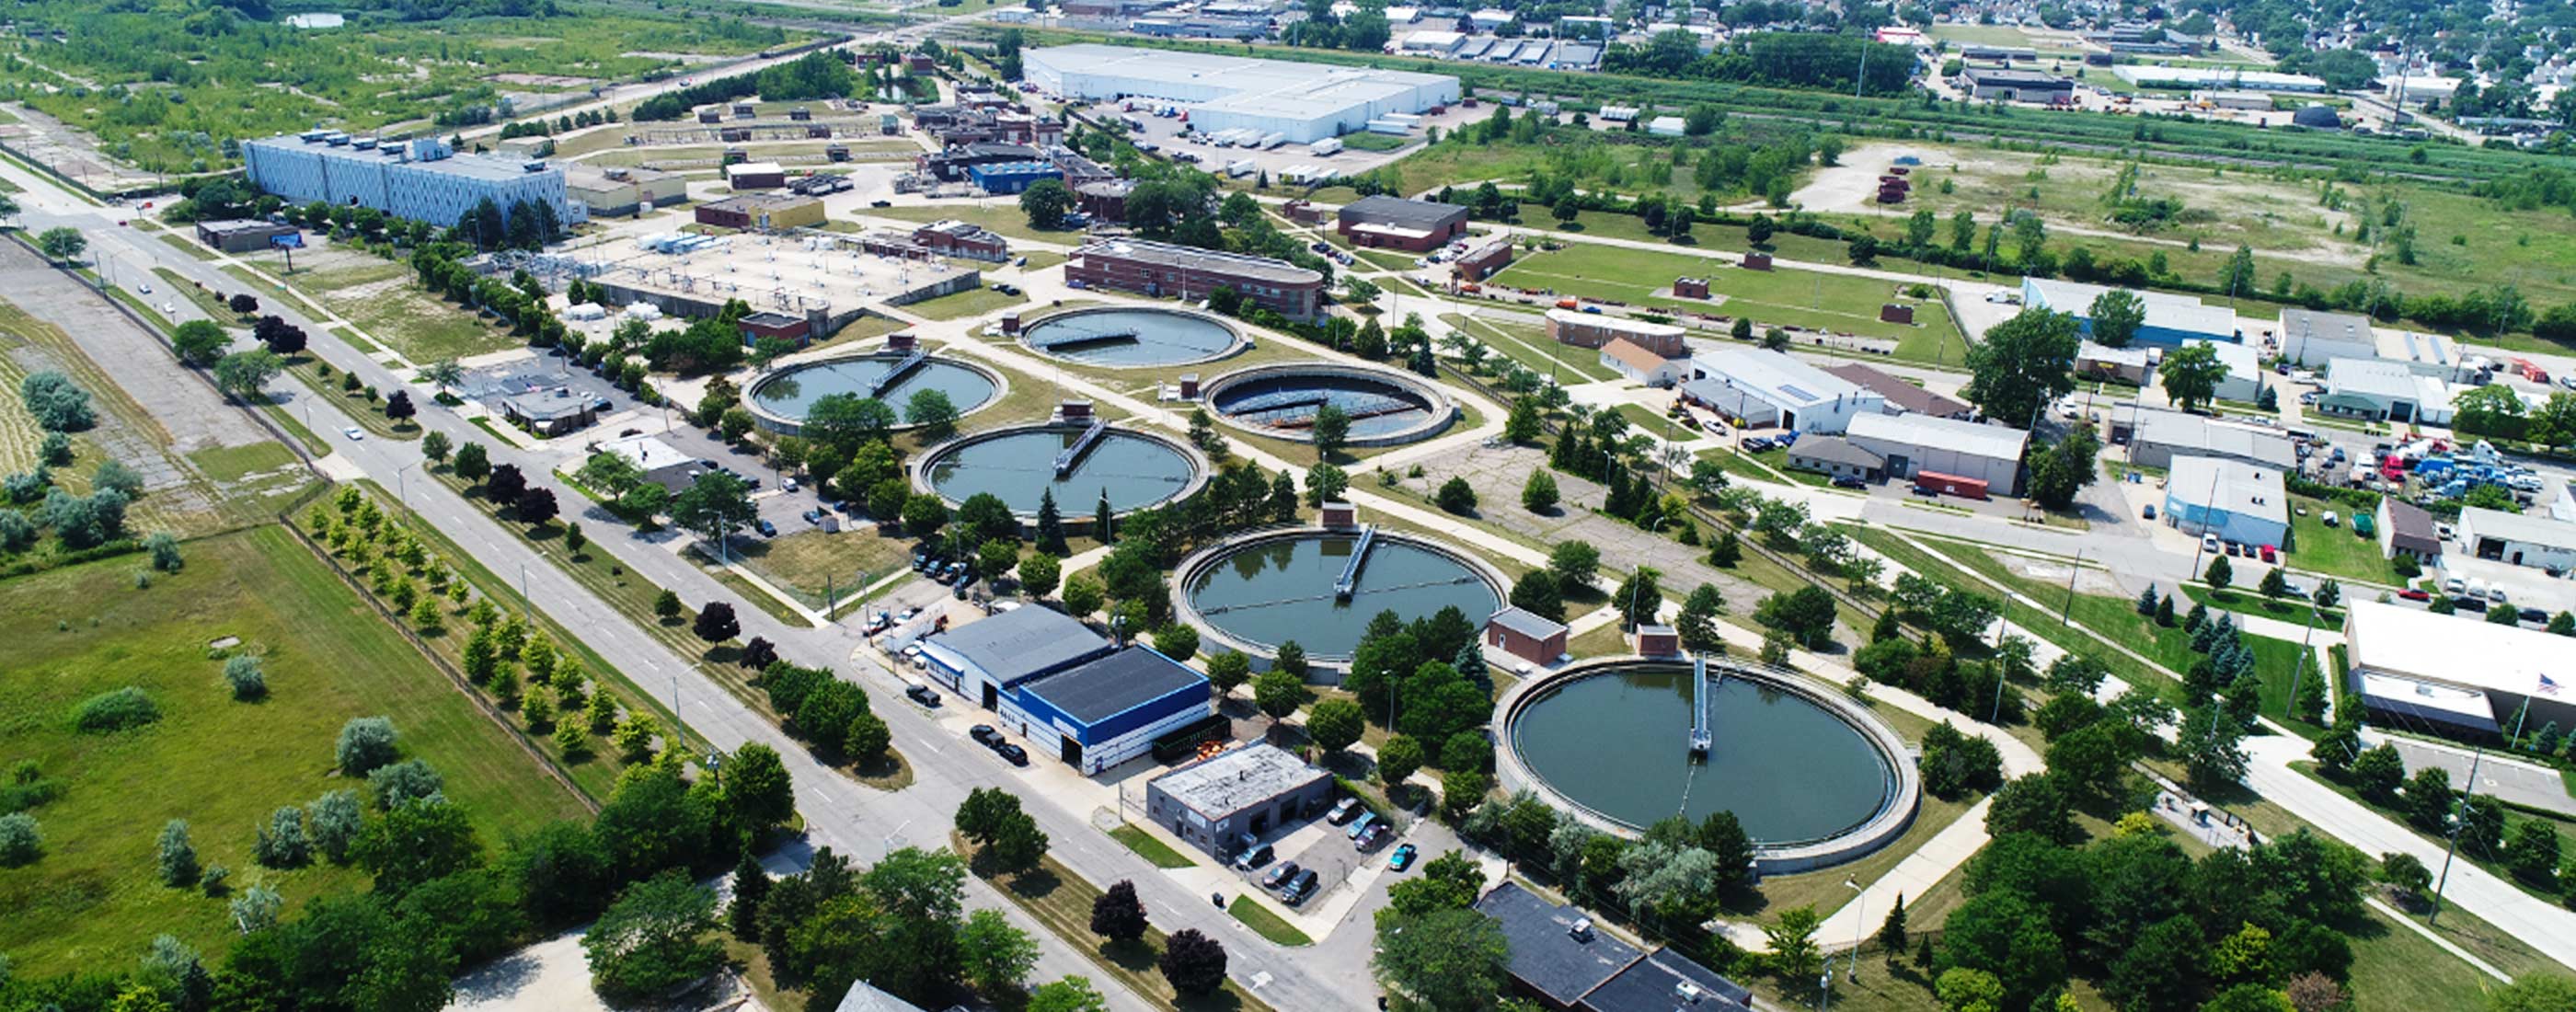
[1201,363,1458,445]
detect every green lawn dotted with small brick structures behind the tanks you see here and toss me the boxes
[1491,242,1961,347]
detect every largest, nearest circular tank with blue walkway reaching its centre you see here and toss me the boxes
[1497,660,1916,870]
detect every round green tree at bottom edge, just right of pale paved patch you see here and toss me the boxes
[582,868,724,999]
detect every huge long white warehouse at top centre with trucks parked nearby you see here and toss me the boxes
[1020,44,1458,142]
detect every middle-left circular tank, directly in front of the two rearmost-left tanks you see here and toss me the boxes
[914,425,1208,520]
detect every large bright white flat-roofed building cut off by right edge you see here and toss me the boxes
[2344,597,2576,737]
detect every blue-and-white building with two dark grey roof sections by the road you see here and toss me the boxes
[922,605,1208,775]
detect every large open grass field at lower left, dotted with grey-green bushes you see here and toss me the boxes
[0,525,582,976]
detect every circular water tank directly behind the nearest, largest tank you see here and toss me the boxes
[1179,531,1501,661]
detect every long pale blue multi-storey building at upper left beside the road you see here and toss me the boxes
[242,129,582,224]
